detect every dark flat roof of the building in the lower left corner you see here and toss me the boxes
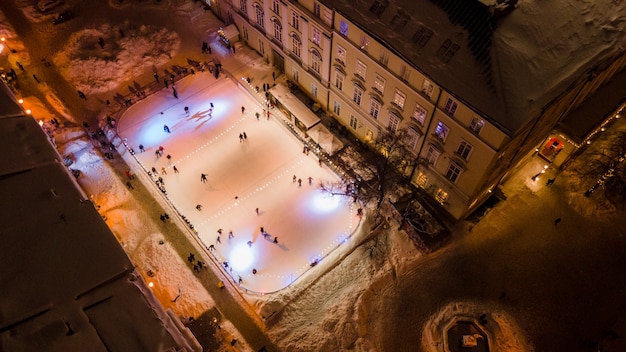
[0,86,189,351]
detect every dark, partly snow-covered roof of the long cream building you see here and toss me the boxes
[322,0,626,133]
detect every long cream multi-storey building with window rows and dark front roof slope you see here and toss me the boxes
[211,0,624,219]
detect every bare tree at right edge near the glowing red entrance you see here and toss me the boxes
[576,131,626,206]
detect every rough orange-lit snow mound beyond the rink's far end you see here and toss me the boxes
[53,22,180,95]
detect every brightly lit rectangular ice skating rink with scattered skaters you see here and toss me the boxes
[118,73,359,293]
